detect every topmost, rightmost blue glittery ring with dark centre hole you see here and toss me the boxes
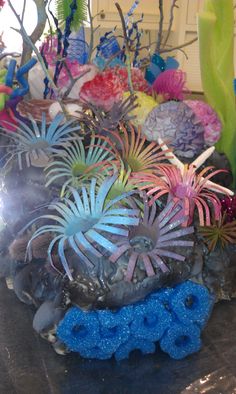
[170,281,214,327]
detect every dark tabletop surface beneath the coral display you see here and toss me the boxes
[0,282,236,394]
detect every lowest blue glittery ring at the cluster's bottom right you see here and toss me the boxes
[160,323,201,360]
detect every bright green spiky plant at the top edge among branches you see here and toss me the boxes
[56,0,87,31]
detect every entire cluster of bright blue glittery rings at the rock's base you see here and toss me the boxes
[57,281,214,360]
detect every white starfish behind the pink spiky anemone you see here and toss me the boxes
[158,138,234,196]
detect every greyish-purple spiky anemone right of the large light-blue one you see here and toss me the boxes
[110,200,194,281]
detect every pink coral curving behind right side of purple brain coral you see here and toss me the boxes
[185,100,222,145]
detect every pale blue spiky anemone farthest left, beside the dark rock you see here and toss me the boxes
[3,113,80,170]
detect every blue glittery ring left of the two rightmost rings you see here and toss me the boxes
[130,299,172,342]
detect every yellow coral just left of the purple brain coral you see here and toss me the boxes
[124,92,158,126]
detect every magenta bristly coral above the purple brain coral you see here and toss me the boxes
[152,70,188,101]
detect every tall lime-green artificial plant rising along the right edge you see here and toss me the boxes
[198,0,236,188]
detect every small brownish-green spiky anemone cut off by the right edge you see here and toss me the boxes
[199,214,236,252]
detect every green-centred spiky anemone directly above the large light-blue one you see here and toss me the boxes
[45,136,119,196]
